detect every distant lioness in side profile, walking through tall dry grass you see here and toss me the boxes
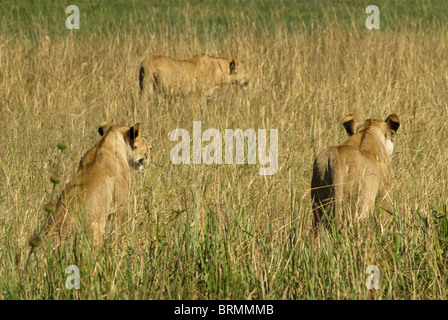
[139,53,251,99]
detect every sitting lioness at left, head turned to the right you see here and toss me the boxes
[30,122,151,246]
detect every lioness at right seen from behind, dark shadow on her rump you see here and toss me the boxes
[311,114,400,229]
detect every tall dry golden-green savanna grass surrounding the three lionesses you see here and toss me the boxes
[0,0,448,299]
